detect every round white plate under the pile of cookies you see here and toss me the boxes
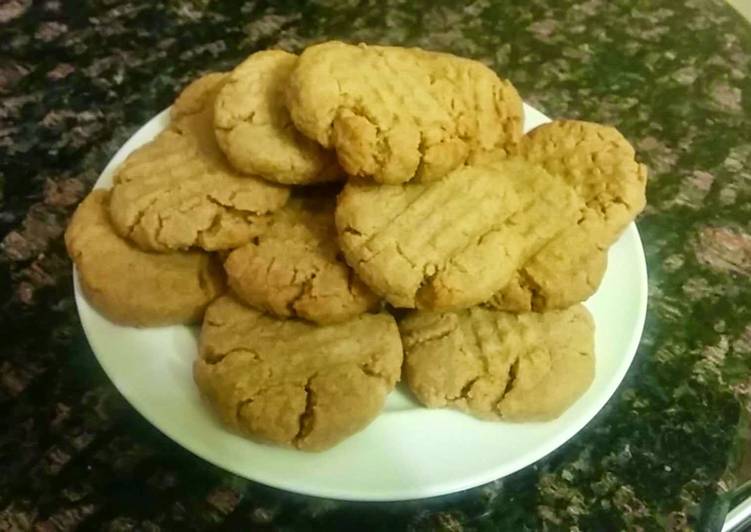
[75,106,647,501]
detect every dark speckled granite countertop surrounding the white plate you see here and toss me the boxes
[0,0,751,531]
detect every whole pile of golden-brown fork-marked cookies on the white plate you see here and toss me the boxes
[66,42,646,450]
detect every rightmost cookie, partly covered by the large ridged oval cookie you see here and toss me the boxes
[490,120,647,312]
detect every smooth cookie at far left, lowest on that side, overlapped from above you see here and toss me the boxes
[65,190,224,327]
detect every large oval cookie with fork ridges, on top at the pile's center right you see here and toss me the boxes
[335,159,581,310]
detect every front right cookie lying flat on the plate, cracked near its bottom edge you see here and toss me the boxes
[399,305,595,421]
